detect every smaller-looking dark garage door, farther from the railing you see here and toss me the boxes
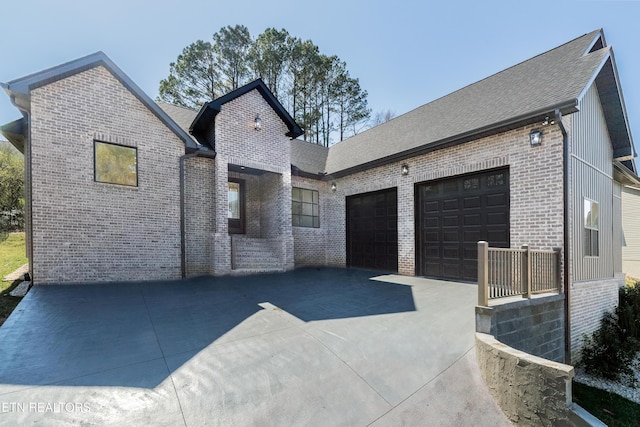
[347,188,398,271]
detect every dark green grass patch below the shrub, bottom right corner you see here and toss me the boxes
[573,382,640,427]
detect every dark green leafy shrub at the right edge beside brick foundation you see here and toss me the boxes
[581,286,640,385]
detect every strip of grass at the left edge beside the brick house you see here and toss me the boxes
[0,233,27,325]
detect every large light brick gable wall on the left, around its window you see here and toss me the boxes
[30,66,184,284]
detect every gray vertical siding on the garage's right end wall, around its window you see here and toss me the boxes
[570,85,615,281]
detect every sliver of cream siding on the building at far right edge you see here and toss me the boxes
[622,187,640,278]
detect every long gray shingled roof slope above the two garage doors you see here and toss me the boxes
[326,30,610,175]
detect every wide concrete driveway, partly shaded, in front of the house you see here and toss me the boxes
[0,268,510,426]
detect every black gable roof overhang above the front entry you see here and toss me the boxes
[189,79,304,148]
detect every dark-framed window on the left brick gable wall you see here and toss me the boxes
[94,141,138,187]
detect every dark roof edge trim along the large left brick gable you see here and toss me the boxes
[0,52,198,149]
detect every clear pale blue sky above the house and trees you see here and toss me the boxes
[0,0,640,154]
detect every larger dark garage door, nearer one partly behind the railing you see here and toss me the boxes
[416,169,509,280]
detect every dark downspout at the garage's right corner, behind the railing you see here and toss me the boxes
[554,109,571,363]
